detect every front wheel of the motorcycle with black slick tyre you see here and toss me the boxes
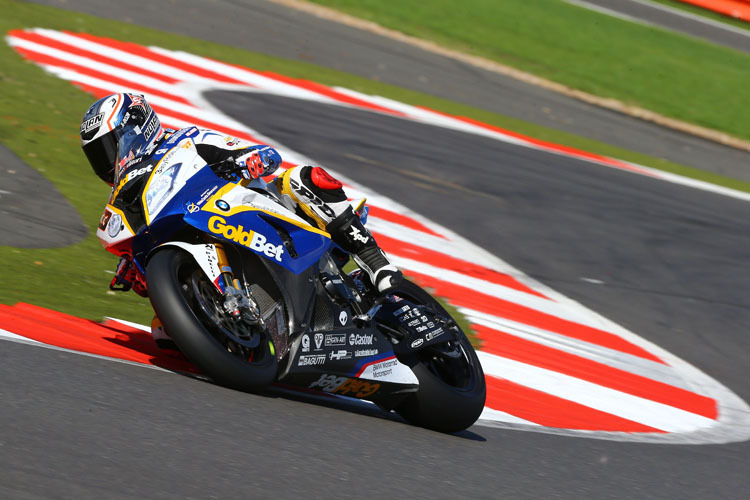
[146,247,278,391]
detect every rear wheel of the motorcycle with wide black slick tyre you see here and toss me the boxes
[393,280,487,432]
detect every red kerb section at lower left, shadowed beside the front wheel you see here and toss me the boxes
[0,304,198,373]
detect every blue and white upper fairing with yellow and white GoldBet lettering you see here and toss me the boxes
[133,129,331,273]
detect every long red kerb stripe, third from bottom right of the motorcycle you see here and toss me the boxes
[406,269,666,364]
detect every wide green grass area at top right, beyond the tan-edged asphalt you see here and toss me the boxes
[313,0,750,143]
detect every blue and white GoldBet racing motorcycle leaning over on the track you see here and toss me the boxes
[97,128,486,432]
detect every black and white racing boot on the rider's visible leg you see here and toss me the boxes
[326,206,403,295]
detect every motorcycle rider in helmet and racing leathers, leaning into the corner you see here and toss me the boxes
[81,93,402,344]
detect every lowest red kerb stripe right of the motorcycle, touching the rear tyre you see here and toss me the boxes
[485,376,664,433]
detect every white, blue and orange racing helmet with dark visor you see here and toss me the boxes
[81,94,164,185]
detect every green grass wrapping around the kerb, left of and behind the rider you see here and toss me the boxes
[0,0,750,332]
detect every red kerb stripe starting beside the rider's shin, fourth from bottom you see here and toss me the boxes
[373,232,547,299]
